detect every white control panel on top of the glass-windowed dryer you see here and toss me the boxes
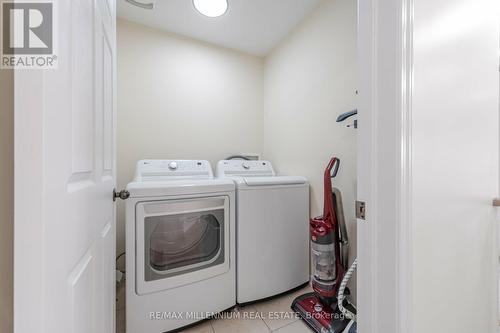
[135,160,214,182]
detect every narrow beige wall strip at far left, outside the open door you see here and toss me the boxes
[0,69,14,333]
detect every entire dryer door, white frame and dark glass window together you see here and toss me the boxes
[136,196,230,295]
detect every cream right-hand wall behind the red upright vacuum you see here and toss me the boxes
[264,0,357,294]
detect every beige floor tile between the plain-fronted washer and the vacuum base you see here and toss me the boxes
[254,286,312,330]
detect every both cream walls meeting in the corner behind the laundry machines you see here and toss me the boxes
[118,0,357,290]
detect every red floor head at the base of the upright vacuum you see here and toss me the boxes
[292,293,356,333]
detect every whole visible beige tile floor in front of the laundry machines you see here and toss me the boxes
[116,282,311,333]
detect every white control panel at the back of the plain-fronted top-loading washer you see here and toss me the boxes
[217,160,276,177]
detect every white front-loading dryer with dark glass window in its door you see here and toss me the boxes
[126,160,236,333]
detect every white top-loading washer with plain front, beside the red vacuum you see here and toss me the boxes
[217,160,309,304]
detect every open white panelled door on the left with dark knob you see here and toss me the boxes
[14,0,116,333]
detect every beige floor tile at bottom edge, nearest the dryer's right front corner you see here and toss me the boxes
[211,306,270,333]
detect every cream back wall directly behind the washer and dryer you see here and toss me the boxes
[117,20,263,252]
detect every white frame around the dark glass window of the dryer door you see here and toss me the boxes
[135,196,230,295]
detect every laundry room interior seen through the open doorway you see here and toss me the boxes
[116,0,359,333]
